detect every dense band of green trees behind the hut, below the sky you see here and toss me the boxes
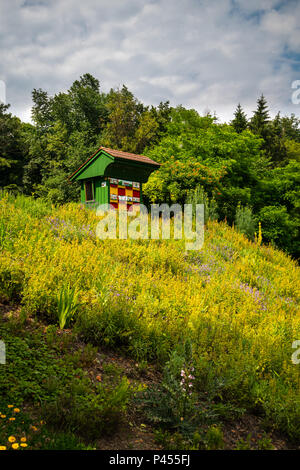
[0,74,300,257]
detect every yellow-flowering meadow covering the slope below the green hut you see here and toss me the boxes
[0,194,300,448]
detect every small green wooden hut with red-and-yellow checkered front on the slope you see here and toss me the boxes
[69,147,160,209]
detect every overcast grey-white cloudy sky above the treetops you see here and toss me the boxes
[0,0,300,121]
